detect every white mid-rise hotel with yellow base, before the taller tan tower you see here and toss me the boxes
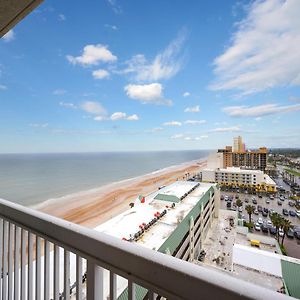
[201,167,276,192]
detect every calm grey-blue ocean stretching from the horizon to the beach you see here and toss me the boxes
[0,150,209,206]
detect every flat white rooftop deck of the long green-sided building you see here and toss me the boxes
[95,181,214,250]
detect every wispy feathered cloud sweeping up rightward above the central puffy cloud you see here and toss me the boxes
[121,32,185,81]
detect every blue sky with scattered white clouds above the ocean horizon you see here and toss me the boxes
[0,0,300,153]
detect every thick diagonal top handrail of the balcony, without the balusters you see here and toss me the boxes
[0,199,293,300]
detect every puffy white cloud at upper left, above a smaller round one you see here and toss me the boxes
[67,44,117,66]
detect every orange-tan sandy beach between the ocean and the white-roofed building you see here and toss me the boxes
[36,160,206,228]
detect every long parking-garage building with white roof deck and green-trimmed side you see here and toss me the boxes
[95,181,220,300]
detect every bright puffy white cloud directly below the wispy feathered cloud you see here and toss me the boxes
[124,83,172,105]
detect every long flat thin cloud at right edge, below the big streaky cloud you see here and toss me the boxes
[223,104,300,117]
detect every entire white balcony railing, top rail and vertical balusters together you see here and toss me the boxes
[0,199,289,300]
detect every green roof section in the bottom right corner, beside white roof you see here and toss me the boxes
[281,259,300,299]
